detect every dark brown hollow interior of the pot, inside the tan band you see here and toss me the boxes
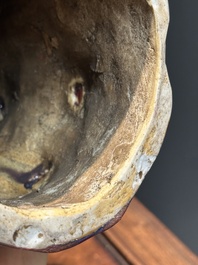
[0,0,152,204]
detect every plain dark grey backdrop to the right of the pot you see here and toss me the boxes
[137,0,198,254]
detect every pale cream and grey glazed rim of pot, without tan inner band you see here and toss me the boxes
[0,0,172,251]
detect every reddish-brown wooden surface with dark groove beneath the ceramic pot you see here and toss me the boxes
[48,198,198,265]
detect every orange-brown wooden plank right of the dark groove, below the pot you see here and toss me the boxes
[105,199,198,265]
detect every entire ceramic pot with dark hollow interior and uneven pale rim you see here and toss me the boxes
[0,0,171,252]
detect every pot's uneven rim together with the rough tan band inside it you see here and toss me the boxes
[0,0,171,251]
